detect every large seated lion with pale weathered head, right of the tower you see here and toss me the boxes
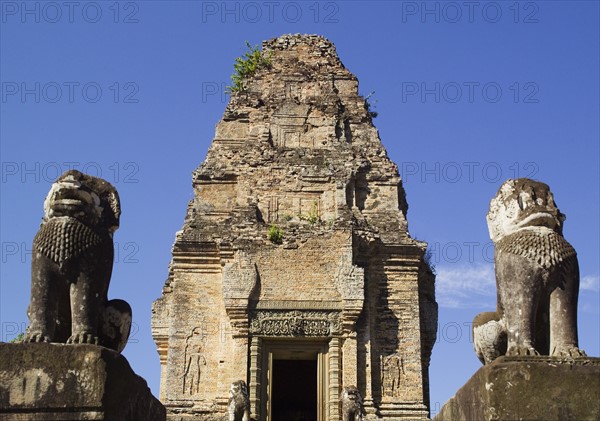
[473,178,585,364]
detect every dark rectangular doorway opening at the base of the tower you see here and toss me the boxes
[271,359,317,421]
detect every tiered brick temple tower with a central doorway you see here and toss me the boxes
[152,35,437,421]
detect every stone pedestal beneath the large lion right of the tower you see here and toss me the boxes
[434,357,600,421]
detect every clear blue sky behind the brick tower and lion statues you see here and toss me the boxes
[0,1,600,413]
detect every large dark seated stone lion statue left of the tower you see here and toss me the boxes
[24,170,131,352]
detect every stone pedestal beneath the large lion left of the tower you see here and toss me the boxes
[0,343,166,421]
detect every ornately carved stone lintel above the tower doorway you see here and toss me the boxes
[250,310,342,337]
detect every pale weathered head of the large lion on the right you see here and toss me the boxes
[487,178,566,242]
